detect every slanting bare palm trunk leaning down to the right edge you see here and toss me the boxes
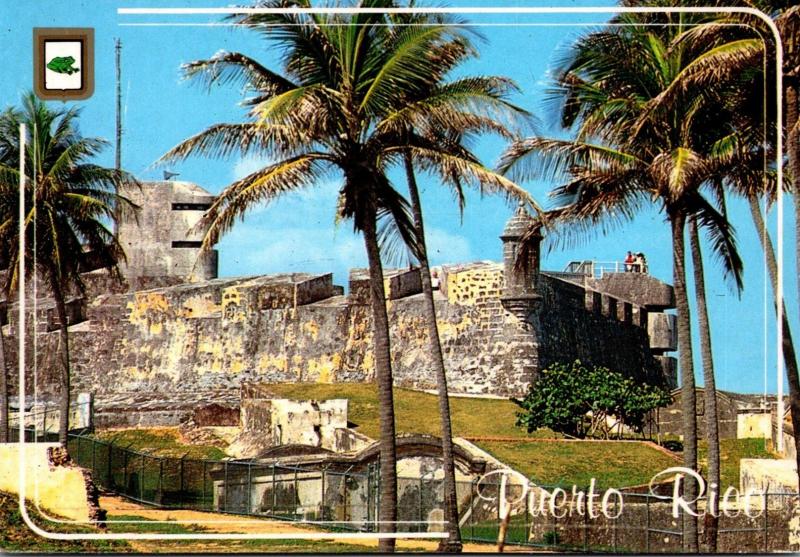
[747,197,800,484]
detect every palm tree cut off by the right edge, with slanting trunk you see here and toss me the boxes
[631,0,800,486]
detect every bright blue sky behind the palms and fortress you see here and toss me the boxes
[0,0,800,392]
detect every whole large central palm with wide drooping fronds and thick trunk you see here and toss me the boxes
[162,0,529,551]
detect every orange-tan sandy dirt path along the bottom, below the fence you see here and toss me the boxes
[100,497,530,553]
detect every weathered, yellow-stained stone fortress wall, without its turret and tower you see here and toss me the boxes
[7,263,676,425]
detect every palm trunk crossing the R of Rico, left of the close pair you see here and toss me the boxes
[670,210,698,553]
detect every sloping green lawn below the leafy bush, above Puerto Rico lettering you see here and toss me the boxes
[479,440,678,488]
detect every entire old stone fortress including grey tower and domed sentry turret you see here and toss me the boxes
[6,189,675,426]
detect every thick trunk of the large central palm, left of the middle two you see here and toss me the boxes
[363,203,397,552]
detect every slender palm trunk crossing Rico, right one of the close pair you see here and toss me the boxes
[689,217,720,553]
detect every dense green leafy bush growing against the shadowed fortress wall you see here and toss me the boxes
[514,360,672,439]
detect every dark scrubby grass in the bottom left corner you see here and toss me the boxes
[0,491,133,555]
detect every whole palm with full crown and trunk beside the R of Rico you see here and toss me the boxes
[501,15,741,551]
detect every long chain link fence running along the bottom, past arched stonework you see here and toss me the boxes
[68,434,796,553]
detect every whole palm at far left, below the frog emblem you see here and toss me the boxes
[0,93,133,446]
